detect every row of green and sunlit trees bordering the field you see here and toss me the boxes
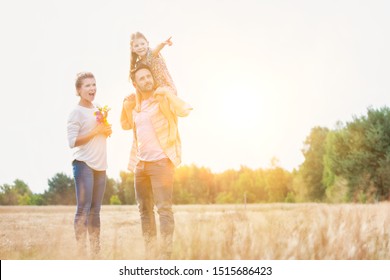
[0,107,390,205]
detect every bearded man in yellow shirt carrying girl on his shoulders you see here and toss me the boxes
[121,64,192,259]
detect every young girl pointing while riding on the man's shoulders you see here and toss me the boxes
[130,32,177,145]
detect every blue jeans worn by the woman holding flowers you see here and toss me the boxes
[72,160,106,253]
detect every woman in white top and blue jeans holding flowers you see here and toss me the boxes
[67,72,112,255]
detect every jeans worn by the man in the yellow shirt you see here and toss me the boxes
[134,158,175,258]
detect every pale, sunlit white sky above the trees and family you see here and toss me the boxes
[0,0,390,193]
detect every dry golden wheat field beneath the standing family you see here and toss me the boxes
[0,203,390,260]
